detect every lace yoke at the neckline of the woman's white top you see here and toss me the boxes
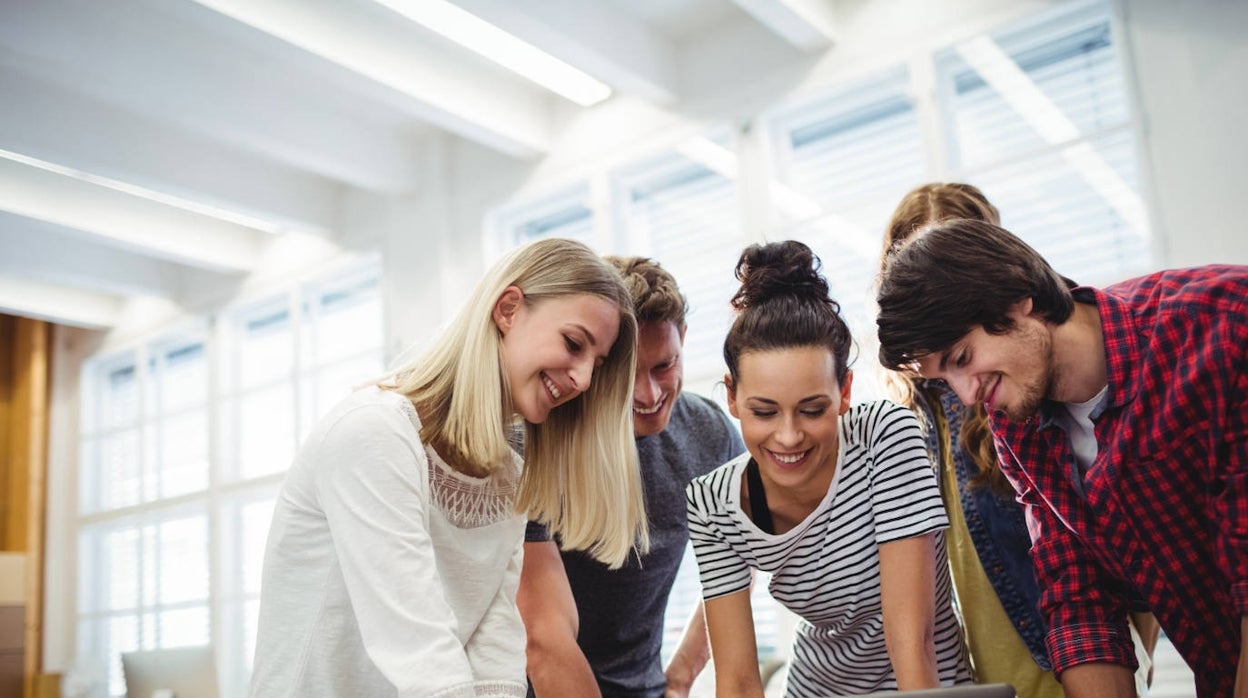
[426,446,520,528]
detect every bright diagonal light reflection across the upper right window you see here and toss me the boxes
[957,36,1148,235]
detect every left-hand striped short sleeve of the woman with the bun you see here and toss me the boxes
[685,460,750,601]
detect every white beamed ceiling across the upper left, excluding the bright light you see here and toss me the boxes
[0,0,831,328]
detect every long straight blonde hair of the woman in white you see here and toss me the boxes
[384,238,649,567]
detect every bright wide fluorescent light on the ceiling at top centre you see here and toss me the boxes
[377,0,612,106]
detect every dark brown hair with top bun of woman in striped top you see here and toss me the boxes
[724,240,854,385]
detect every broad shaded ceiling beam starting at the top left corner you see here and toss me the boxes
[0,0,422,192]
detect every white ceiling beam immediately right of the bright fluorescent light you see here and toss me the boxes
[456,0,676,104]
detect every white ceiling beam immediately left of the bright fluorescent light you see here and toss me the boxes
[185,0,552,159]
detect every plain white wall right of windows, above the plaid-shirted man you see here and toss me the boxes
[1119,0,1248,266]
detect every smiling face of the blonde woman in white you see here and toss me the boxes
[494,286,620,425]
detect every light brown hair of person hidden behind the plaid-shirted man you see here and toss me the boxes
[880,182,1013,496]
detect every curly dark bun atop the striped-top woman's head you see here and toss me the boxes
[731,240,829,311]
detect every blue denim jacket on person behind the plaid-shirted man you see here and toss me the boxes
[915,381,1053,671]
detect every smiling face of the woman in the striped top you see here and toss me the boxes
[728,346,854,499]
